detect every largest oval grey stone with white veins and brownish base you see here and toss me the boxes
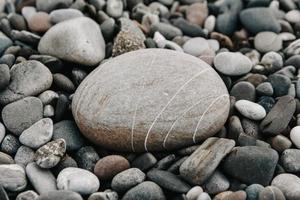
[72,49,230,152]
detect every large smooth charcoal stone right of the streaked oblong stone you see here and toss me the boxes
[223,146,278,186]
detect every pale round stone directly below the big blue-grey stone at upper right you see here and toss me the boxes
[254,31,282,53]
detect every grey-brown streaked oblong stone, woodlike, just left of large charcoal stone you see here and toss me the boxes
[179,137,235,185]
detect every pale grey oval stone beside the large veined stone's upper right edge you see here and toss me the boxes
[214,52,252,76]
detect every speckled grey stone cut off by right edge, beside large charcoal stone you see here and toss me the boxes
[280,149,300,173]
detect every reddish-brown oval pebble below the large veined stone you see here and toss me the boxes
[94,155,130,180]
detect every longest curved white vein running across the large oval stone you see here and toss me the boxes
[144,68,211,151]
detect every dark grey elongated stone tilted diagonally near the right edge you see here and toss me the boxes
[260,95,296,135]
